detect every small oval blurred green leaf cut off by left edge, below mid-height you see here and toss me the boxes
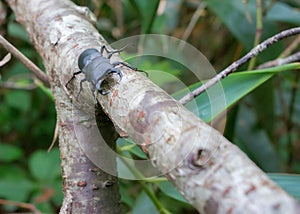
[0,144,23,162]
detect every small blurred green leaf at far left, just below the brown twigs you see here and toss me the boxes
[5,91,31,111]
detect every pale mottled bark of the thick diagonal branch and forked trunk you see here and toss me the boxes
[8,0,300,213]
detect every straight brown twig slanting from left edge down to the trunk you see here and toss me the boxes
[0,35,50,87]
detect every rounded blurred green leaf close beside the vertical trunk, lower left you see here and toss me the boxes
[29,148,61,182]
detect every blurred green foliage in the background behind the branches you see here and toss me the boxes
[0,0,300,213]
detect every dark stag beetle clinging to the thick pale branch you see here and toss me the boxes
[66,45,139,98]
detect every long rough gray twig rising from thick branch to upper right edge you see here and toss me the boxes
[179,27,300,104]
